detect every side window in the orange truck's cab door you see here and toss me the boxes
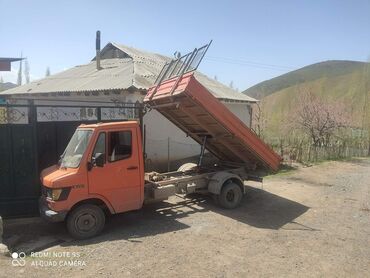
[108,131,132,162]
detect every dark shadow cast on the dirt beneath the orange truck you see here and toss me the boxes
[4,187,310,252]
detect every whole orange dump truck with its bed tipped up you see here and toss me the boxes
[40,45,280,238]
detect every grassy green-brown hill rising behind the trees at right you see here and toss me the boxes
[244,61,370,135]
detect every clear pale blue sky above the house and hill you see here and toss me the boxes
[0,0,370,91]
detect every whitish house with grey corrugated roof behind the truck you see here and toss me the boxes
[3,43,256,170]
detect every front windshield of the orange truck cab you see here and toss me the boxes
[60,129,92,168]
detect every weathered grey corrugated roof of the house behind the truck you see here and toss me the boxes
[1,43,256,102]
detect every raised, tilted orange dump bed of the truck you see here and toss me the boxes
[144,72,281,171]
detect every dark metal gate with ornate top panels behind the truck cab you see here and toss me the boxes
[0,103,142,217]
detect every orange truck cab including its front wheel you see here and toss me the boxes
[40,121,144,238]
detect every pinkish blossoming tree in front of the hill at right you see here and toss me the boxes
[291,90,350,147]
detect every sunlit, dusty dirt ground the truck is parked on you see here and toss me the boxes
[0,159,370,277]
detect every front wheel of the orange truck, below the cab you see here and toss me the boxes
[67,204,105,239]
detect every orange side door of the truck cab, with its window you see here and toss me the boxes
[88,128,143,212]
